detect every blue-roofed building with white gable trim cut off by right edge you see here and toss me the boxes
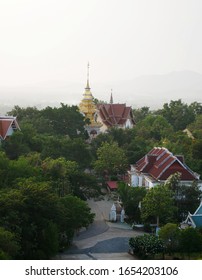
[181,201,202,228]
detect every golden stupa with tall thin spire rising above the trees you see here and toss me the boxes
[79,63,97,126]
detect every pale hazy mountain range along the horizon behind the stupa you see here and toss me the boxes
[0,71,202,112]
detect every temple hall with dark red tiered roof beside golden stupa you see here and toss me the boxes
[97,103,135,132]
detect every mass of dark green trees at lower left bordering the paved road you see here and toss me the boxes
[0,179,94,259]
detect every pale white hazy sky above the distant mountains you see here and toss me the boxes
[0,0,202,105]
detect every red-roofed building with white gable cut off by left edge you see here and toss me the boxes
[0,116,20,141]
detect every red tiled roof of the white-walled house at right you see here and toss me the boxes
[135,147,199,181]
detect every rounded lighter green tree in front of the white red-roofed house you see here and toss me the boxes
[141,185,175,227]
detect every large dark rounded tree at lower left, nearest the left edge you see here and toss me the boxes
[0,179,61,259]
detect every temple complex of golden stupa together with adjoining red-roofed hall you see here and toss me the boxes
[79,64,135,138]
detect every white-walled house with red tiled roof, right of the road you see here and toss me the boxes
[128,147,202,188]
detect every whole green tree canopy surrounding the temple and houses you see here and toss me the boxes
[0,100,202,259]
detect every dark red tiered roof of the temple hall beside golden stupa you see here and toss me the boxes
[97,104,134,127]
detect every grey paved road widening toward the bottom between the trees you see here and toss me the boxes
[57,197,141,260]
